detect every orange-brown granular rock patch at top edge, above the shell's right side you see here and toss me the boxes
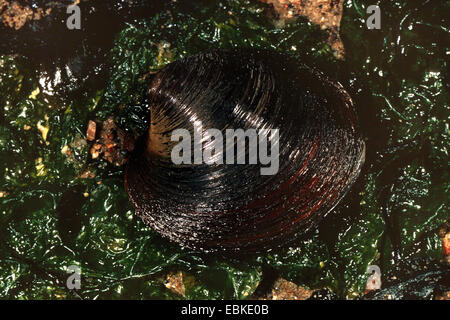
[261,0,345,59]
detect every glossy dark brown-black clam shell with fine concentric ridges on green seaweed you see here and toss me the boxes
[125,50,365,252]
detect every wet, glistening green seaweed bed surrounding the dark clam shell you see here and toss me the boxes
[0,0,450,299]
